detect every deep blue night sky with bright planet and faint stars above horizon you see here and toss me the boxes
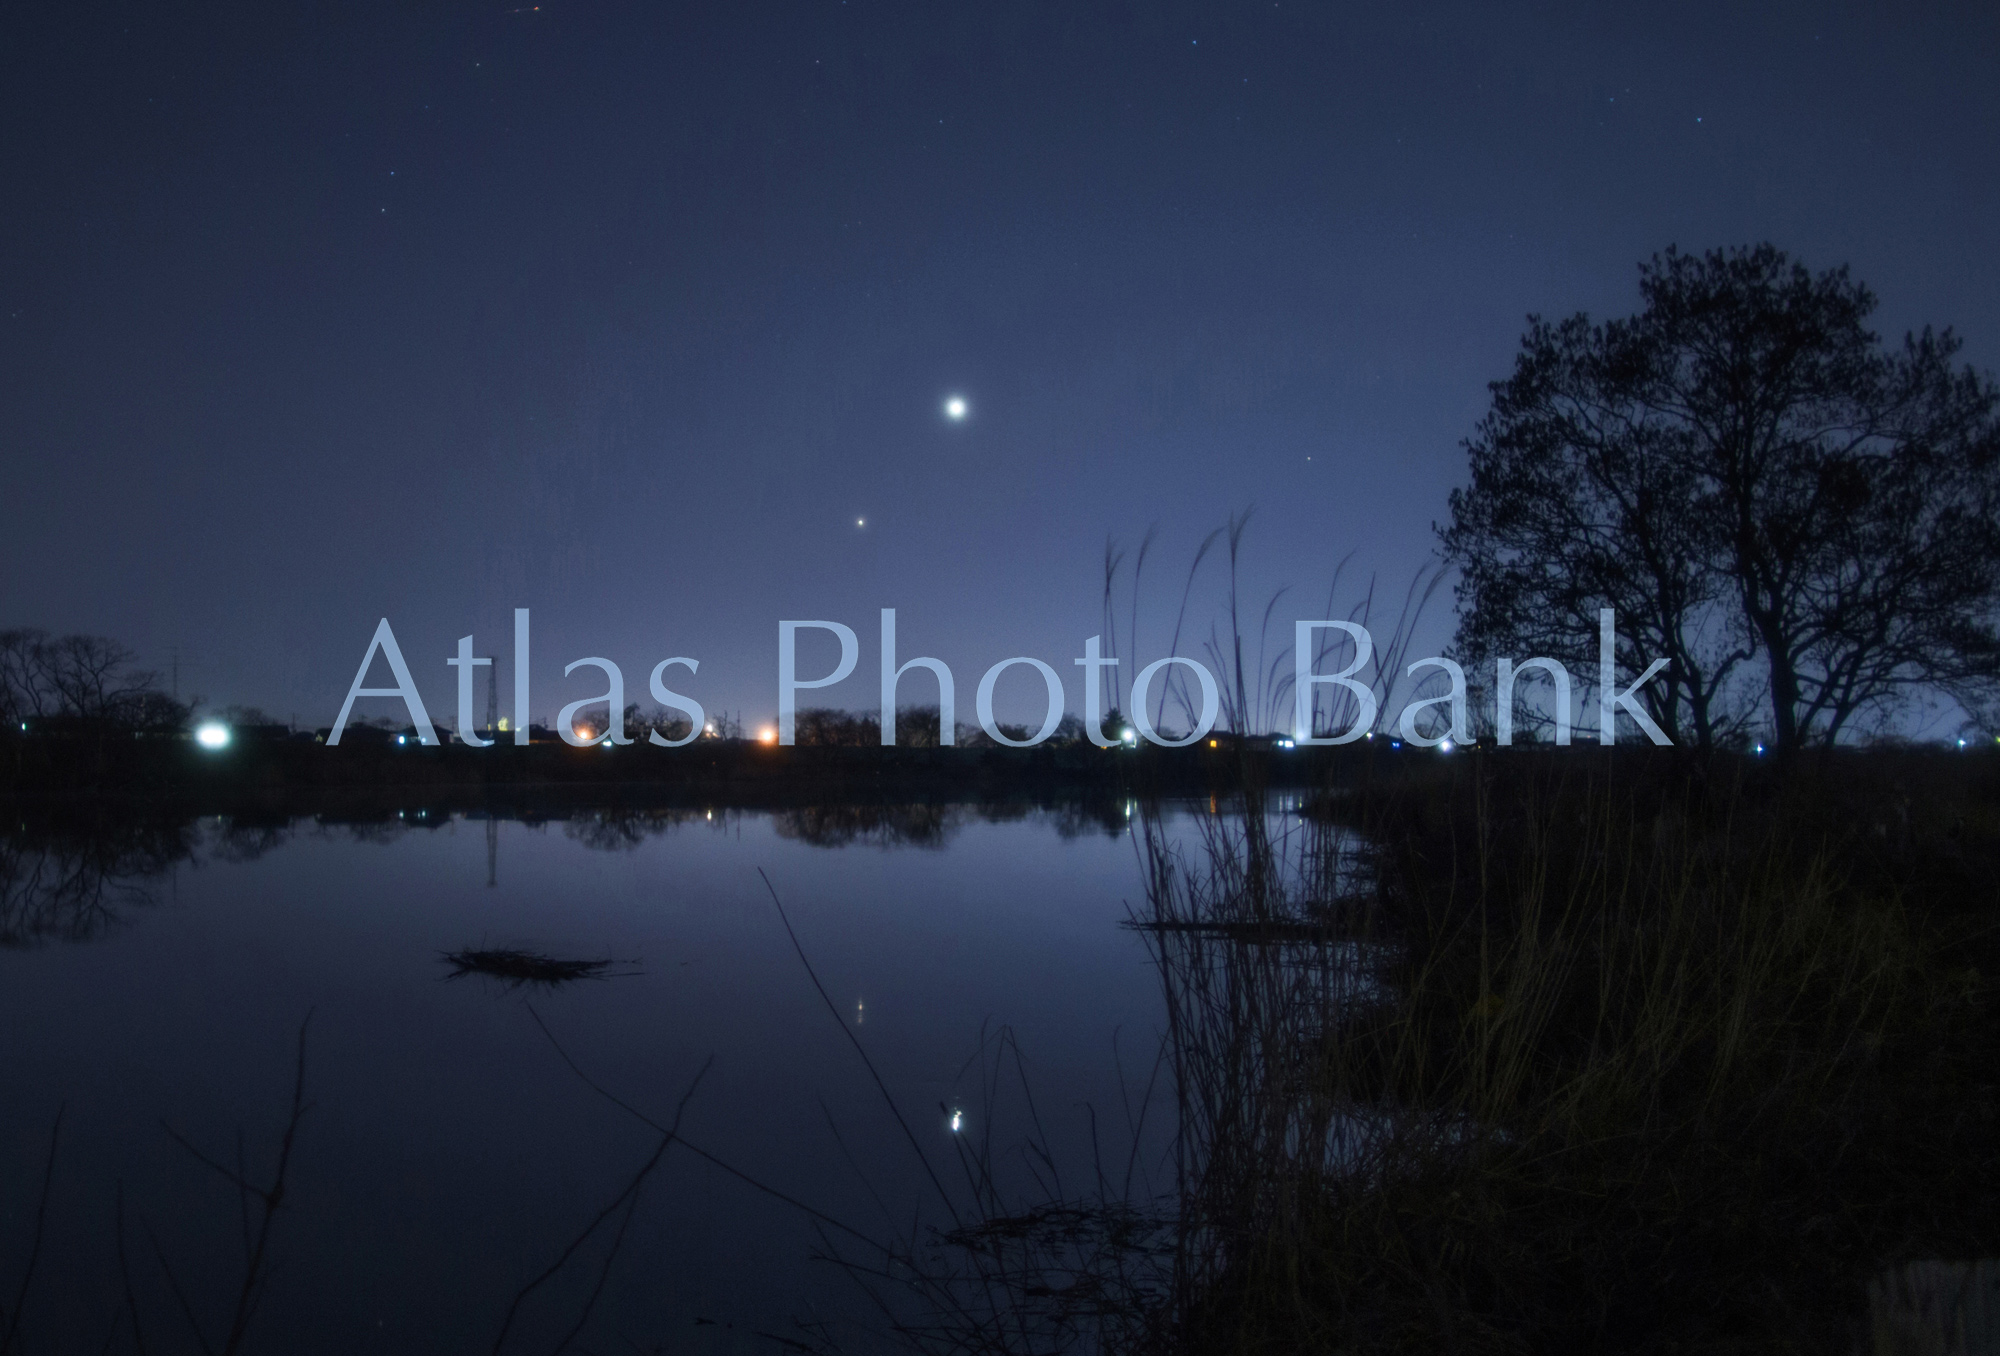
[0,0,2000,726]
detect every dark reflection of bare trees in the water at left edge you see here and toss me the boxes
[0,824,194,946]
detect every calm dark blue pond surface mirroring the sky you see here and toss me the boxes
[0,806,1192,1352]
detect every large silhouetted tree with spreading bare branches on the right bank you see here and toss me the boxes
[1440,244,2000,750]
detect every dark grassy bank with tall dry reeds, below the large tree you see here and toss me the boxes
[1136,758,1996,1352]
